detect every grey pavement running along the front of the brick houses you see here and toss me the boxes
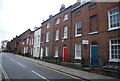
[14,55,120,81]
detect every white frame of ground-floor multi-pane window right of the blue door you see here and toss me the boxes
[109,38,120,62]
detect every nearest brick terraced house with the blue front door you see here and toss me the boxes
[70,2,120,66]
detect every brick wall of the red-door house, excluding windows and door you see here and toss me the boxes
[41,6,72,60]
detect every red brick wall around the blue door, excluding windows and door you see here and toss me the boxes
[70,2,120,65]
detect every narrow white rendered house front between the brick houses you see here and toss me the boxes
[33,28,41,58]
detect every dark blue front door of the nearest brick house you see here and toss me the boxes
[91,46,98,66]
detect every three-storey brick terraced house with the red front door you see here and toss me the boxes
[41,4,72,61]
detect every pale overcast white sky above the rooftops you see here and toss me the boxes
[0,0,77,45]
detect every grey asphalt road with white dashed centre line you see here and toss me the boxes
[1,53,84,81]
